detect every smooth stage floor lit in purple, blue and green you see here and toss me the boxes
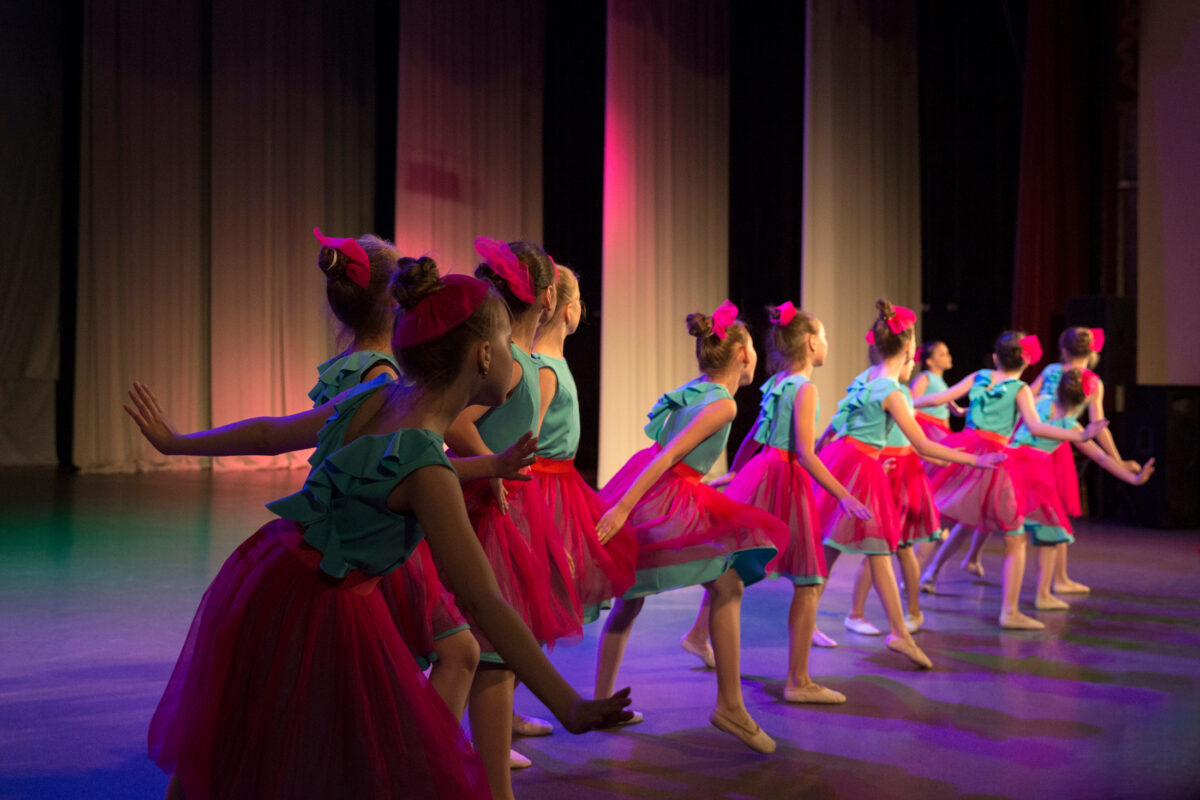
[0,471,1200,800]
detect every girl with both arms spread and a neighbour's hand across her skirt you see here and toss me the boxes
[917,331,1108,630]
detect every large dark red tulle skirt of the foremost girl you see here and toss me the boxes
[149,519,491,800]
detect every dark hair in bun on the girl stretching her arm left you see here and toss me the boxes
[317,234,400,338]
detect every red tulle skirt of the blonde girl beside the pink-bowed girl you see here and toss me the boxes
[533,458,637,609]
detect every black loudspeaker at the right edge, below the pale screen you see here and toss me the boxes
[1123,383,1200,528]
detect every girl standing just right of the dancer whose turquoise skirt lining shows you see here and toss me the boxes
[694,302,871,703]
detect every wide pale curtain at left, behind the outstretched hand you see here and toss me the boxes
[74,0,374,471]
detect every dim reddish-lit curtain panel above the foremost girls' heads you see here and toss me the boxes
[396,0,544,272]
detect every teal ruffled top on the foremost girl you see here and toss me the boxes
[266,429,454,578]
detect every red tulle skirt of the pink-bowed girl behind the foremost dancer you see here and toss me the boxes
[463,480,583,661]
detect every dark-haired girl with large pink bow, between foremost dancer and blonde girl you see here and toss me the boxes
[446,236,583,798]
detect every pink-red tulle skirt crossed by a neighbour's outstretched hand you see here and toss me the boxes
[931,428,1025,533]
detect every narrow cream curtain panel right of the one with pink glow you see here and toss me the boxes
[802,0,920,427]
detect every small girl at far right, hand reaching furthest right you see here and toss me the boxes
[1010,367,1154,610]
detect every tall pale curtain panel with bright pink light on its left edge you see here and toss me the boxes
[598,0,729,485]
